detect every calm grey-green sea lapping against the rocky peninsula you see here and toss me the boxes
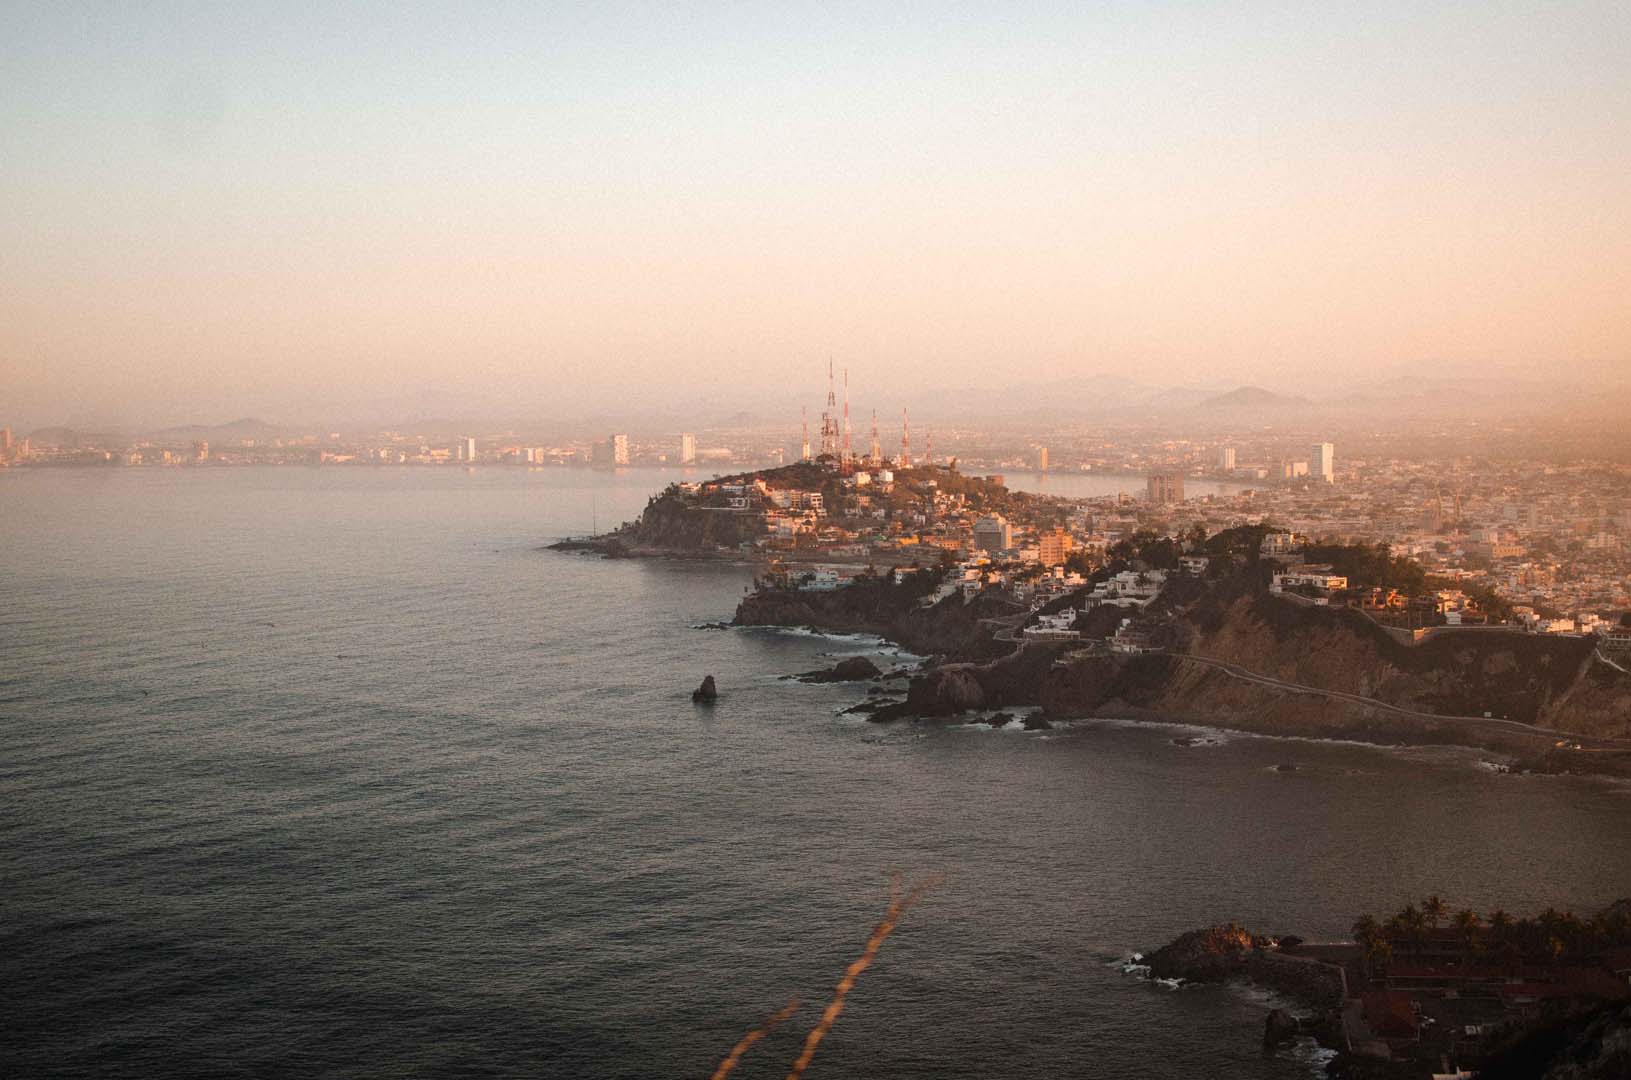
[0,468,1631,1078]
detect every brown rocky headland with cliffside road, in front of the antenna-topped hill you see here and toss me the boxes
[732,574,1631,777]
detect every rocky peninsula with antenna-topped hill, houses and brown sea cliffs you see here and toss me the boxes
[553,463,1631,777]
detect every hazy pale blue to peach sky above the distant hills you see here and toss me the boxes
[0,0,1631,427]
